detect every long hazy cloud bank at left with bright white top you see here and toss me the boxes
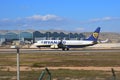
[0,14,69,29]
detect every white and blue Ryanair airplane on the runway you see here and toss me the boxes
[34,27,101,51]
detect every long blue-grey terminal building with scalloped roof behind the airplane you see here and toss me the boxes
[0,30,85,44]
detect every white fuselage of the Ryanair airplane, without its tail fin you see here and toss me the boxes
[34,40,94,47]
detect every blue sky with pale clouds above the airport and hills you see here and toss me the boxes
[0,0,120,33]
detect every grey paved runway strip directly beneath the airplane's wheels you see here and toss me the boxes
[0,49,120,53]
